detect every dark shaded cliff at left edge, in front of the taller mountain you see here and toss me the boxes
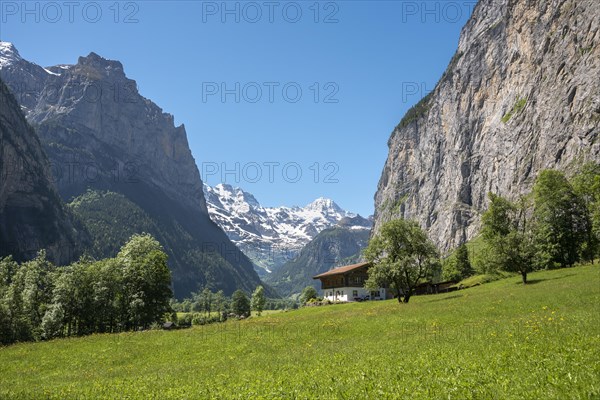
[0,79,86,264]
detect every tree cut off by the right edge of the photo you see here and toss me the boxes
[572,162,600,263]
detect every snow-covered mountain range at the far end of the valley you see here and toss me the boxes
[204,184,371,273]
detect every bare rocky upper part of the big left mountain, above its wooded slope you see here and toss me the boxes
[0,42,207,214]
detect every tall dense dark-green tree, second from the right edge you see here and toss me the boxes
[533,170,591,268]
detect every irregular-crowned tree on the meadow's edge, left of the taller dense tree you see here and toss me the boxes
[482,193,534,284]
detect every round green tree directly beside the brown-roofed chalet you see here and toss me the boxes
[364,219,439,303]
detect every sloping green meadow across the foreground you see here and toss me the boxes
[0,266,600,399]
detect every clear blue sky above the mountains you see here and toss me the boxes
[0,0,476,215]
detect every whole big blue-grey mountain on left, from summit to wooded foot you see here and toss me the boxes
[0,42,268,298]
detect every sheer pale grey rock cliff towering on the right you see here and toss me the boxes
[375,0,600,250]
